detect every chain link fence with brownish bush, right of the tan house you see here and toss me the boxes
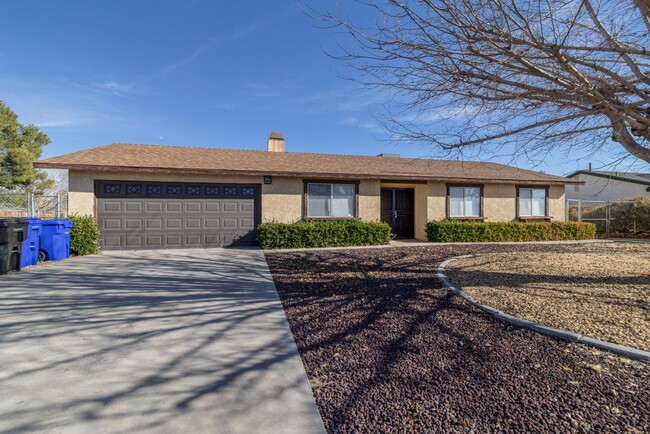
[566,199,650,238]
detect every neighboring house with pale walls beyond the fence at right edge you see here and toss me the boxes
[566,170,650,201]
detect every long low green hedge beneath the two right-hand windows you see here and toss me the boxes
[427,220,596,243]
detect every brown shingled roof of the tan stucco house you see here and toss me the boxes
[35,144,577,184]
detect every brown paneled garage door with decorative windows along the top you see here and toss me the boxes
[95,181,261,250]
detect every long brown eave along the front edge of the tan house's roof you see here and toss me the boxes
[34,161,584,185]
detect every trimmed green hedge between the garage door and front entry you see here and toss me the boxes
[257,220,394,249]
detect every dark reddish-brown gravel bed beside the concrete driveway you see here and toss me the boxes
[267,245,650,433]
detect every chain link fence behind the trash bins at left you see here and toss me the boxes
[0,192,68,218]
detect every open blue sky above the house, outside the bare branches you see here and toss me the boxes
[0,0,644,174]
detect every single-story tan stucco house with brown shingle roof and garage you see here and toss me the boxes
[36,133,576,249]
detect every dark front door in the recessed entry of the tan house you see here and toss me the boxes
[381,188,415,238]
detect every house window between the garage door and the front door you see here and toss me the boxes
[307,183,356,218]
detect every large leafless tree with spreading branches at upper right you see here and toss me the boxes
[317,0,650,162]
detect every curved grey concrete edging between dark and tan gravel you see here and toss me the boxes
[436,253,650,362]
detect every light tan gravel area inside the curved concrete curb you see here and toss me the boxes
[447,243,650,350]
